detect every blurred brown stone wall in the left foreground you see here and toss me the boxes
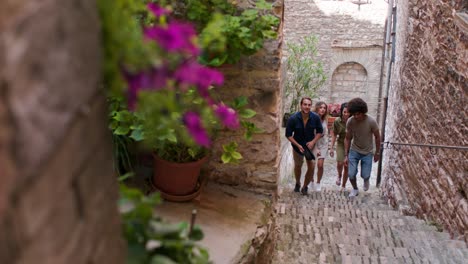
[0,0,125,263]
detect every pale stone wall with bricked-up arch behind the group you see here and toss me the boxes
[284,0,387,117]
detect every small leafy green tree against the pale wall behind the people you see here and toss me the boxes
[285,35,327,113]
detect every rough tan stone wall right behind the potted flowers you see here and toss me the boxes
[204,0,283,192]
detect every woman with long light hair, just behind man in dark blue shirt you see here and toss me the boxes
[313,101,328,192]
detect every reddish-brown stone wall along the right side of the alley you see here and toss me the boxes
[382,0,468,240]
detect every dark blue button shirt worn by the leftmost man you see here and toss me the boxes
[286,111,323,155]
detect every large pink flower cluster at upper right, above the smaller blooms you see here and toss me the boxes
[174,61,224,104]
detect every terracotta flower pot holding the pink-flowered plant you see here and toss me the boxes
[153,154,208,195]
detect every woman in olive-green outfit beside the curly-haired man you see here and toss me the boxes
[330,103,349,190]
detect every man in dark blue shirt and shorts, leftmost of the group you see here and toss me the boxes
[286,97,323,195]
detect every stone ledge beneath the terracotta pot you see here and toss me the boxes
[155,182,275,263]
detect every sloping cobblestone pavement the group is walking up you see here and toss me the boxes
[273,159,468,264]
